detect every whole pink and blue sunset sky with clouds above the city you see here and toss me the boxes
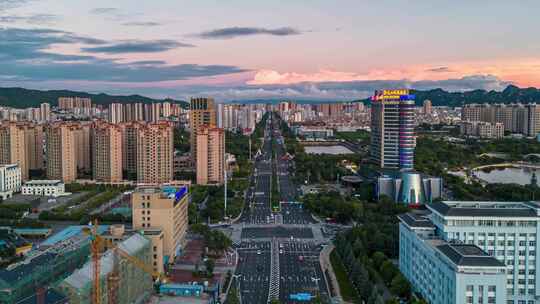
[0,0,540,101]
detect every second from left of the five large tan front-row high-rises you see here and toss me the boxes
[45,123,77,183]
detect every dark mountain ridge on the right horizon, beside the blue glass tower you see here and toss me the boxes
[363,85,540,107]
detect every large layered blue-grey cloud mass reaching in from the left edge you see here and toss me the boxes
[0,28,246,83]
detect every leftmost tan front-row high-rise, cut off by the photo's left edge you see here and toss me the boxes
[0,122,28,180]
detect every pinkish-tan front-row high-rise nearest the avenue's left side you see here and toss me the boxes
[197,126,225,185]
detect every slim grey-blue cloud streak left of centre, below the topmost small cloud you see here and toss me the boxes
[82,40,195,54]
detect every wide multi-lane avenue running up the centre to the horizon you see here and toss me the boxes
[232,116,329,304]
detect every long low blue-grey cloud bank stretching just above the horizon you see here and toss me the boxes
[0,72,511,102]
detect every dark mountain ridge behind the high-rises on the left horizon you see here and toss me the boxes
[0,88,189,108]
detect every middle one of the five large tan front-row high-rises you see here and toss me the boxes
[92,123,122,182]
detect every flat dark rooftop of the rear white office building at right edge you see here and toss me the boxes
[427,201,540,218]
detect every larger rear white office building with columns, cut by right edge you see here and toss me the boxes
[412,201,540,304]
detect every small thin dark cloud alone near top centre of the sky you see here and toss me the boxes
[195,27,301,39]
